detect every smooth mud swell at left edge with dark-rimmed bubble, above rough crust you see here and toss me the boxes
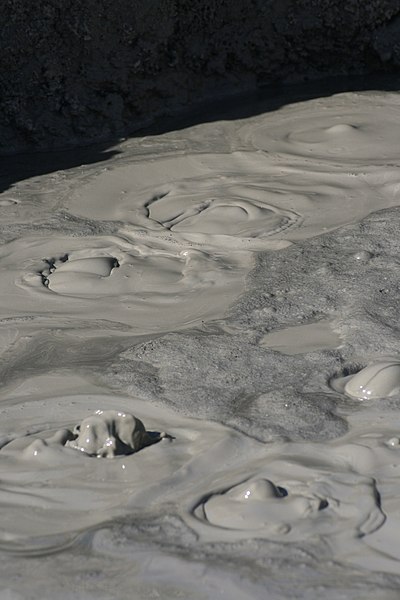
[0,236,252,334]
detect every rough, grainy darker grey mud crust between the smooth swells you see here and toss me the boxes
[104,208,400,441]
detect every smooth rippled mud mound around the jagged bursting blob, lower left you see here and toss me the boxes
[0,374,262,551]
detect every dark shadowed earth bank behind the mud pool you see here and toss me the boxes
[0,0,400,153]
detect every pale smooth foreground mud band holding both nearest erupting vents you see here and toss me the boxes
[0,374,400,576]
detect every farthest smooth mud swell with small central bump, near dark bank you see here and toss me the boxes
[240,94,400,170]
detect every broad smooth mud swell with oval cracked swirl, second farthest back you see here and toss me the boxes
[67,150,399,246]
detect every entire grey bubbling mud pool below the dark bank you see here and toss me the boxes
[0,86,400,600]
